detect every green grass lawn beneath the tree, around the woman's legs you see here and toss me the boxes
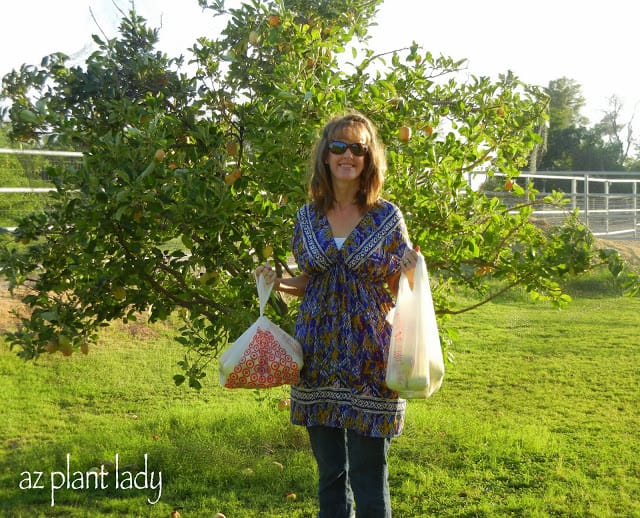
[0,278,640,518]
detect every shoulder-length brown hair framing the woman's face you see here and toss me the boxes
[309,111,387,214]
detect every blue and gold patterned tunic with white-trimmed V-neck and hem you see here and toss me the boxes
[291,200,409,437]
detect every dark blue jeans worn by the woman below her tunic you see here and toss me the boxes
[307,426,391,518]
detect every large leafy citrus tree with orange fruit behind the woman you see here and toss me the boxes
[0,0,636,388]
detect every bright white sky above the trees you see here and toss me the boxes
[0,0,640,123]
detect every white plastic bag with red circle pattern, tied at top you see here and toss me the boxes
[219,275,302,388]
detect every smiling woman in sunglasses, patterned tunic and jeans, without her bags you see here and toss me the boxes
[256,113,417,518]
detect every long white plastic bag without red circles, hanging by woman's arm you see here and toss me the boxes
[386,252,444,399]
